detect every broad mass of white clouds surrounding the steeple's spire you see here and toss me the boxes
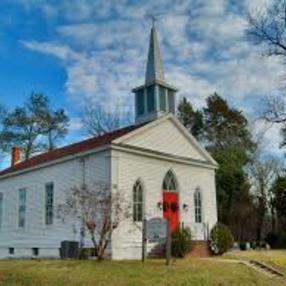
[19,0,284,156]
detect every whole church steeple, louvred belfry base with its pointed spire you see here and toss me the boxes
[132,22,178,123]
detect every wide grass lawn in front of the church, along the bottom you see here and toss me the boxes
[0,258,282,286]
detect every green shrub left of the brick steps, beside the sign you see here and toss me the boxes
[172,228,193,258]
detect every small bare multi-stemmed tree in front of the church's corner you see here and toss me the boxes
[58,184,130,260]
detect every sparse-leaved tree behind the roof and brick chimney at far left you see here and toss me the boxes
[0,93,68,159]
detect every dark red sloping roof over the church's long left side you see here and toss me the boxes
[0,124,144,177]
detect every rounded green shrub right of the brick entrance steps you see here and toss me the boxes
[210,223,234,255]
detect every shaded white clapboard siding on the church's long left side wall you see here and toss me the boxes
[0,151,110,257]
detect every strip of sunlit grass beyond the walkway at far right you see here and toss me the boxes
[223,250,286,275]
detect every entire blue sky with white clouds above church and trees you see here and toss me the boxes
[0,0,284,160]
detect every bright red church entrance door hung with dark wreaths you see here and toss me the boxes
[163,191,179,233]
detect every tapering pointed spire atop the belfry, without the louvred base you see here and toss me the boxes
[145,22,165,84]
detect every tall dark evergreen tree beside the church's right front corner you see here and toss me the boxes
[203,93,255,237]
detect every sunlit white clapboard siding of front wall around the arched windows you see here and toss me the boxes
[112,151,217,259]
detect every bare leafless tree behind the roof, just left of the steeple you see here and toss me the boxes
[82,104,131,136]
